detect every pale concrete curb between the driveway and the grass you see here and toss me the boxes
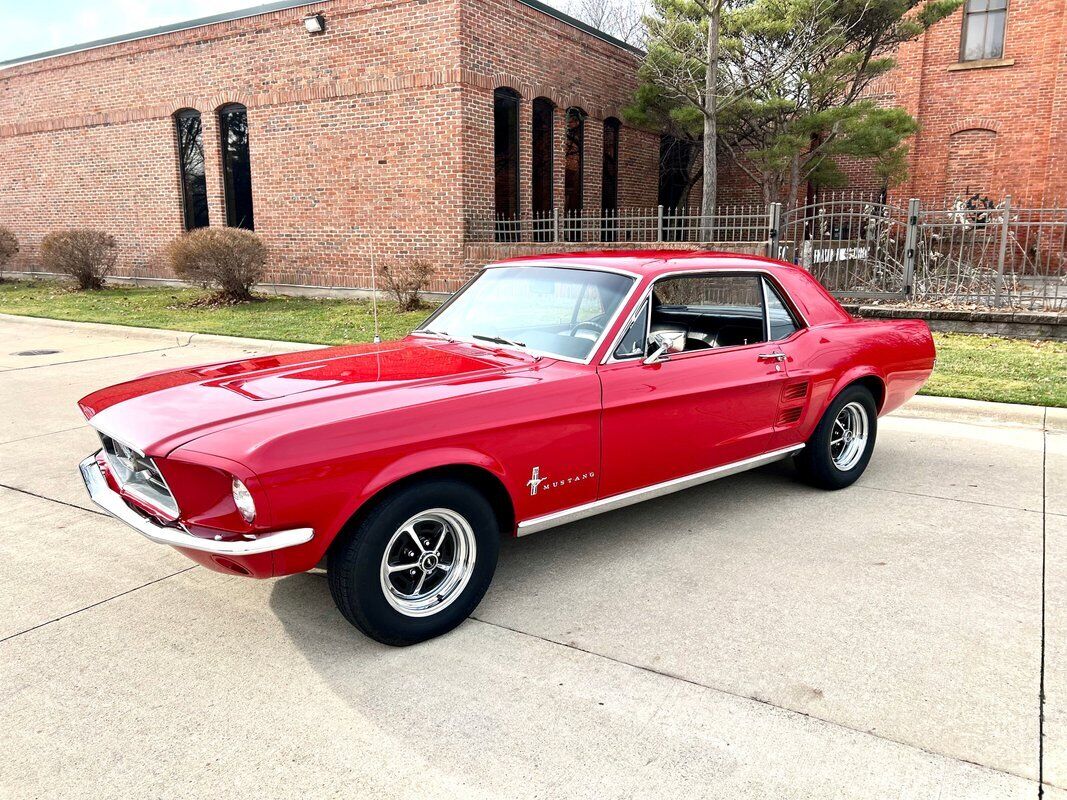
[0,314,1067,432]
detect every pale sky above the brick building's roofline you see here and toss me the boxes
[0,0,584,61]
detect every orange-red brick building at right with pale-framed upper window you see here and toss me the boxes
[882,0,1067,205]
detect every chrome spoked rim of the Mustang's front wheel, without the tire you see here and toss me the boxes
[379,508,478,618]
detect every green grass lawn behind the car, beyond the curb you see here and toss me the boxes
[0,282,1067,407]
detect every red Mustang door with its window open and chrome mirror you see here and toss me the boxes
[599,270,786,497]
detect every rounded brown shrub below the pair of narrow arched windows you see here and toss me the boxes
[163,228,267,303]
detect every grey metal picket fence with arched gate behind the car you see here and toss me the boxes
[467,194,1067,310]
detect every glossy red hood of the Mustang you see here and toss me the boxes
[78,337,535,455]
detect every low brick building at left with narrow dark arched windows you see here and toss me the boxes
[0,0,658,289]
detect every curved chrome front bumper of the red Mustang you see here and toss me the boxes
[78,453,315,556]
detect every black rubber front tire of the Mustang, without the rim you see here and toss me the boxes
[327,479,500,646]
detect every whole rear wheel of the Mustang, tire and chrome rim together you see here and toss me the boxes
[796,386,878,490]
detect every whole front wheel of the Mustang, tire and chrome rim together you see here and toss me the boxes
[327,480,499,645]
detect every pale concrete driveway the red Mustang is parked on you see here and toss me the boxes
[0,319,1067,800]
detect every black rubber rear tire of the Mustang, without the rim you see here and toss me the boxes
[796,386,878,490]
